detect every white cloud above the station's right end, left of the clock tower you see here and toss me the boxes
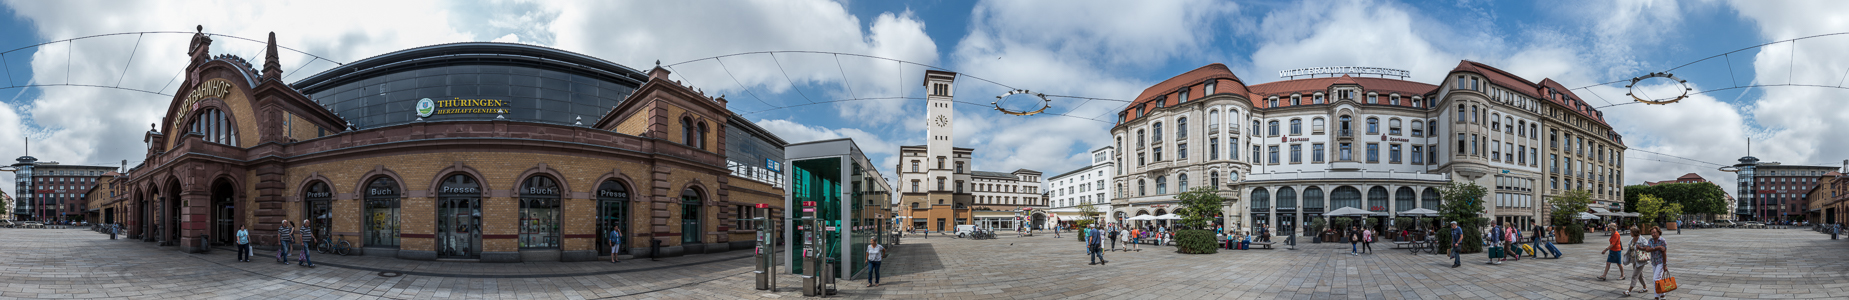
[547,0,937,126]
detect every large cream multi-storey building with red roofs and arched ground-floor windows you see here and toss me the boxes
[1109,61,1619,233]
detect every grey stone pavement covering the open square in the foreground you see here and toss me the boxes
[0,230,1849,298]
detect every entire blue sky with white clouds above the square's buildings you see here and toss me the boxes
[0,0,1849,201]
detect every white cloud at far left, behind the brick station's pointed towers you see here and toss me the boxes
[0,0,471,199]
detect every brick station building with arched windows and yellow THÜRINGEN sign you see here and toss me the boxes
[107,28,788,261]
